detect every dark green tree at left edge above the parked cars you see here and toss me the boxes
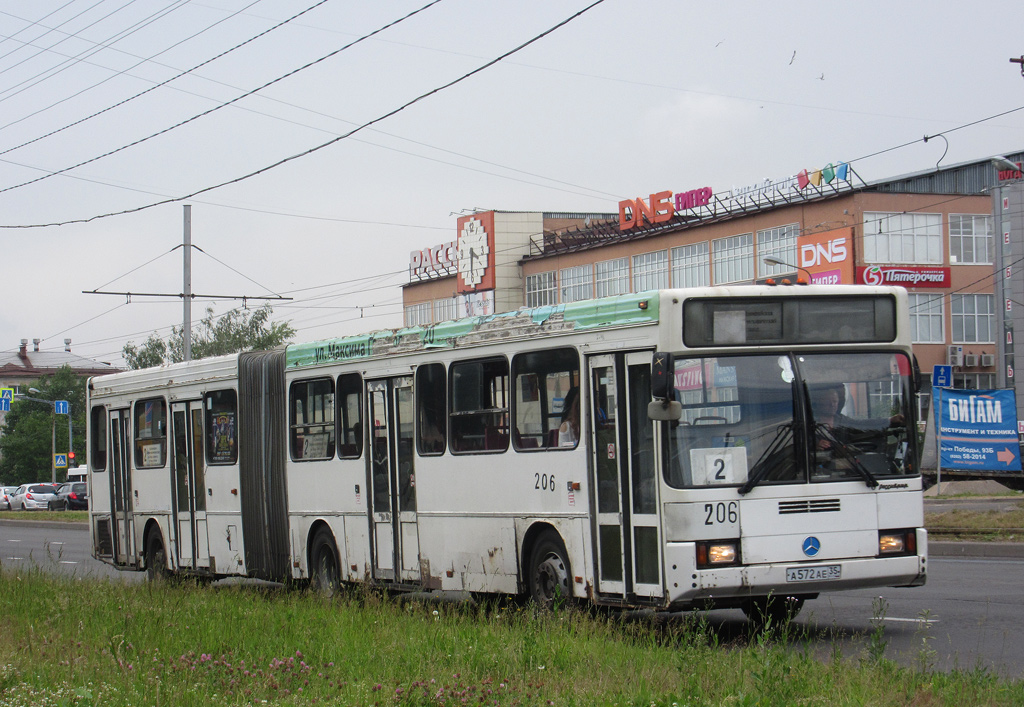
[0,366,86,486]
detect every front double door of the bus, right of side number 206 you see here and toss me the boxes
[589,351,664,598]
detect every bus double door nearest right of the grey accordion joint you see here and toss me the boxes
[367,376,420,582]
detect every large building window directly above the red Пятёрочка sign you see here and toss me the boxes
[864,211,942,264]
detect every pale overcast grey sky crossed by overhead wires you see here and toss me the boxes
[0,0,1024,365]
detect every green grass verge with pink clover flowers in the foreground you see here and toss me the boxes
[0,570,1024,707]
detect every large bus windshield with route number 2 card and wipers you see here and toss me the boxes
[666,351,916,487]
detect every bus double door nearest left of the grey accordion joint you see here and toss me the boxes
[171,401,210,570]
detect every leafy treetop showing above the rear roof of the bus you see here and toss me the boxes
[122,304,295,368]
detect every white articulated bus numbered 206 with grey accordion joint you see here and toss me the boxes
[88,286,927,615]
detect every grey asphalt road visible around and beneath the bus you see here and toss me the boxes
[0,519,1024,678]
